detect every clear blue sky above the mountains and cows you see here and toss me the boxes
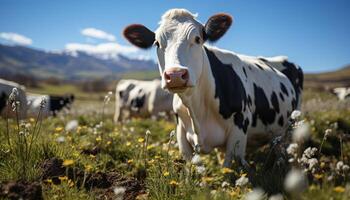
[0,0,350,72]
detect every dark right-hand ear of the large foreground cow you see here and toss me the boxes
[204,13,232,42]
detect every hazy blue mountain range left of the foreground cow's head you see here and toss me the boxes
[0,44,157,80]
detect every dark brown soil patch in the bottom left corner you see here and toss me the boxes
[0,181,43,200]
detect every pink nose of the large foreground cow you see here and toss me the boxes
[164,68,189,88]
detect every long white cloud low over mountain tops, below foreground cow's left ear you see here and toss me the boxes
[65,42,138,59]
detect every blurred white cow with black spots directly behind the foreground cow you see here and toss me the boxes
[114,80,173,122]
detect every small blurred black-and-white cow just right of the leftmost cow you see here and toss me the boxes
[27,93,74,117]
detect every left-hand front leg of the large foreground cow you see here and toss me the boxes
[176,119,193,161]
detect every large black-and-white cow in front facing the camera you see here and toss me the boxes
[123,9,303,167]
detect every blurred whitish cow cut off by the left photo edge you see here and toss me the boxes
[0,79,27,119]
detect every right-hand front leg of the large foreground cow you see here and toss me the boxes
[224,126,249,168]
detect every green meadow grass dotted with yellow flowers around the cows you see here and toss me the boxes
[0,85,350,200]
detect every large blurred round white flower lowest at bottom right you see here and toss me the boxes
[284,169,307,194]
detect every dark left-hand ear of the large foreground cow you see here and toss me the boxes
[123,24,155,49]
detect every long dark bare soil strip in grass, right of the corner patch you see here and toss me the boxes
[41,158,145,199]
